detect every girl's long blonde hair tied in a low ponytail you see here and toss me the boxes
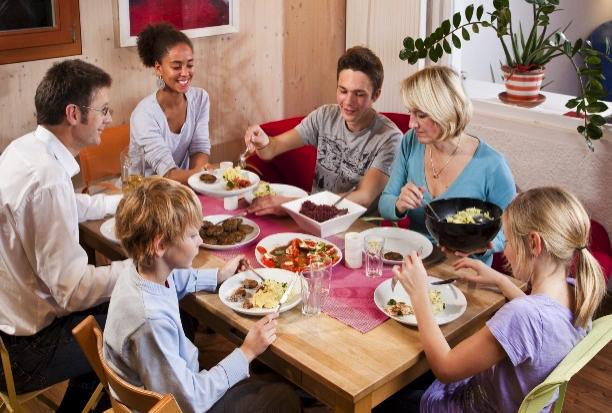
[504,187,606,327]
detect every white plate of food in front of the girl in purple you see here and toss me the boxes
[374,276,467,326]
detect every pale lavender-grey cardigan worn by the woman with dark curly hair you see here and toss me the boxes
[130,87,210,176]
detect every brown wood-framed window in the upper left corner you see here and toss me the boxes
[0,0,81,64]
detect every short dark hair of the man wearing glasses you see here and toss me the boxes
[34,59,112,125]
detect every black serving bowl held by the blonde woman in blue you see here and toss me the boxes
[425,198,503,252]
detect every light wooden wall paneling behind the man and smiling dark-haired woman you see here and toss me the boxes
[0,0,345,161]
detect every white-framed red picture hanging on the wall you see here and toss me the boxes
[117,0,238,47]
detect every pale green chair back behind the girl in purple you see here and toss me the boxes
[519,315,612,413]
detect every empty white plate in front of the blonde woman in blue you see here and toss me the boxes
[361,227,433,264]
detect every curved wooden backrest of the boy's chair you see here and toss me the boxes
[93,327,163,412]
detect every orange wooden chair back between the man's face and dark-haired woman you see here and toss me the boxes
[79,125,130,187]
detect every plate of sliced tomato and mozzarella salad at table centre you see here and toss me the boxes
[255,232,342,272]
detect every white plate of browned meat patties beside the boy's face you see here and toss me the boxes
[200,215,259,250]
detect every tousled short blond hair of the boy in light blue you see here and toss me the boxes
[115,177,202,267]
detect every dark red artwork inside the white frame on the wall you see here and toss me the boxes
[129,0,230,36]
